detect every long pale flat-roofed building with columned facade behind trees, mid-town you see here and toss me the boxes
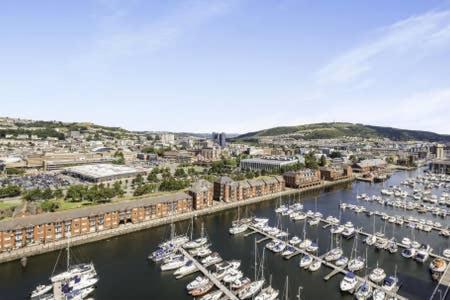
[240,156,300,171]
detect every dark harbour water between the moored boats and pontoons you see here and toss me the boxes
[0,171,450,300]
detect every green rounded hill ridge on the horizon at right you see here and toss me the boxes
[236,122,450,142]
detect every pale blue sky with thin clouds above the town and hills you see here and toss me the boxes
[0,0,450,134]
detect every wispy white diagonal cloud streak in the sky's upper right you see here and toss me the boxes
[317,11,450,84]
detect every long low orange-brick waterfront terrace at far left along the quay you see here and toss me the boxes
[0,193,193,251]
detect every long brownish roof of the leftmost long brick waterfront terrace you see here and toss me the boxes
[0,193,192,231]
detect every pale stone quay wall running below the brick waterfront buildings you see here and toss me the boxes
[0,177,355,263]
